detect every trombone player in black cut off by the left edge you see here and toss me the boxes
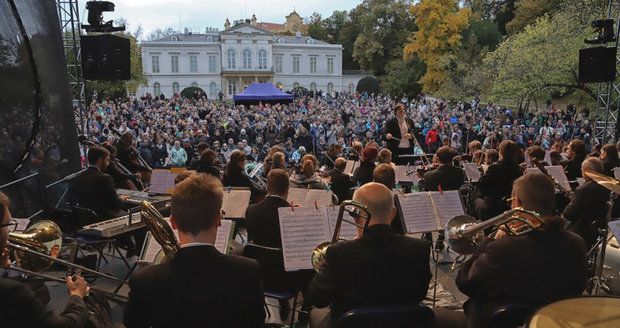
[0,192,89,328]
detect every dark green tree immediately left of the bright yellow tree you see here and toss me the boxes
[352,0,415,75]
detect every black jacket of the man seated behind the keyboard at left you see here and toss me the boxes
[72,166,124,220]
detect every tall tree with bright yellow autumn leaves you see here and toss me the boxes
[404,0,471,93]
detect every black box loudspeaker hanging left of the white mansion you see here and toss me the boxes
[80,34,131,81]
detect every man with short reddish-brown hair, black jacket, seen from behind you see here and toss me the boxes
[124,174,265,328]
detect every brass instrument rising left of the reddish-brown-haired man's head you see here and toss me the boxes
[140,201,181,264]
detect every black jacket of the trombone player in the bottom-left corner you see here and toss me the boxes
[0,278,88,328]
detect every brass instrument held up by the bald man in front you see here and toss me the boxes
[311,200,371,271]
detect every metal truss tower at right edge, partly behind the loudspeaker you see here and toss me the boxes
[592,0,620,145]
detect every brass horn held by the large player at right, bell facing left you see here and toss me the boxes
[445,207,543,255]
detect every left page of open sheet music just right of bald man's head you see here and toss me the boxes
[398,192,438,233]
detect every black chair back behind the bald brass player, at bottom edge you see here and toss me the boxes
[336,304,435,328]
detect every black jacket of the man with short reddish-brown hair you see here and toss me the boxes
[124,246,265,328]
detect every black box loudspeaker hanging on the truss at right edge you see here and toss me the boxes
[579,47,616,83]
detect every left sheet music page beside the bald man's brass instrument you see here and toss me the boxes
[278,206,331,271]
